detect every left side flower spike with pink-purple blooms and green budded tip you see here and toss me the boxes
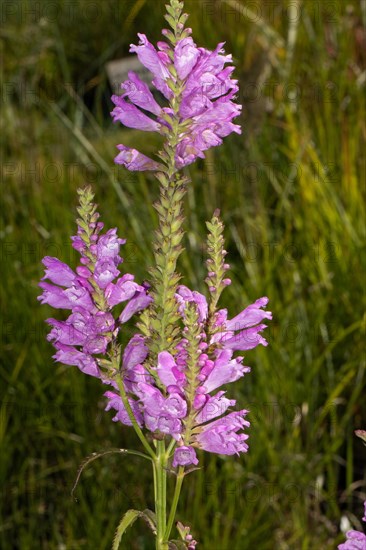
[38,189,151,378]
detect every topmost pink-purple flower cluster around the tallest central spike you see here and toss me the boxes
[111,29,241,170]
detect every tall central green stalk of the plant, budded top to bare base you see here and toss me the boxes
[139,4,187,550]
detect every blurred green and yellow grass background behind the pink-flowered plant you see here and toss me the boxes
[0,0,366,550]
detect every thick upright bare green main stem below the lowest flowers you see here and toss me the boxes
[154,440,168,550]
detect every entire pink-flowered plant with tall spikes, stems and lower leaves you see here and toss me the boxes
[39,0,271,550]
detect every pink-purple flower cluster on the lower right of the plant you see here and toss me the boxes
[105,286,271,466]
